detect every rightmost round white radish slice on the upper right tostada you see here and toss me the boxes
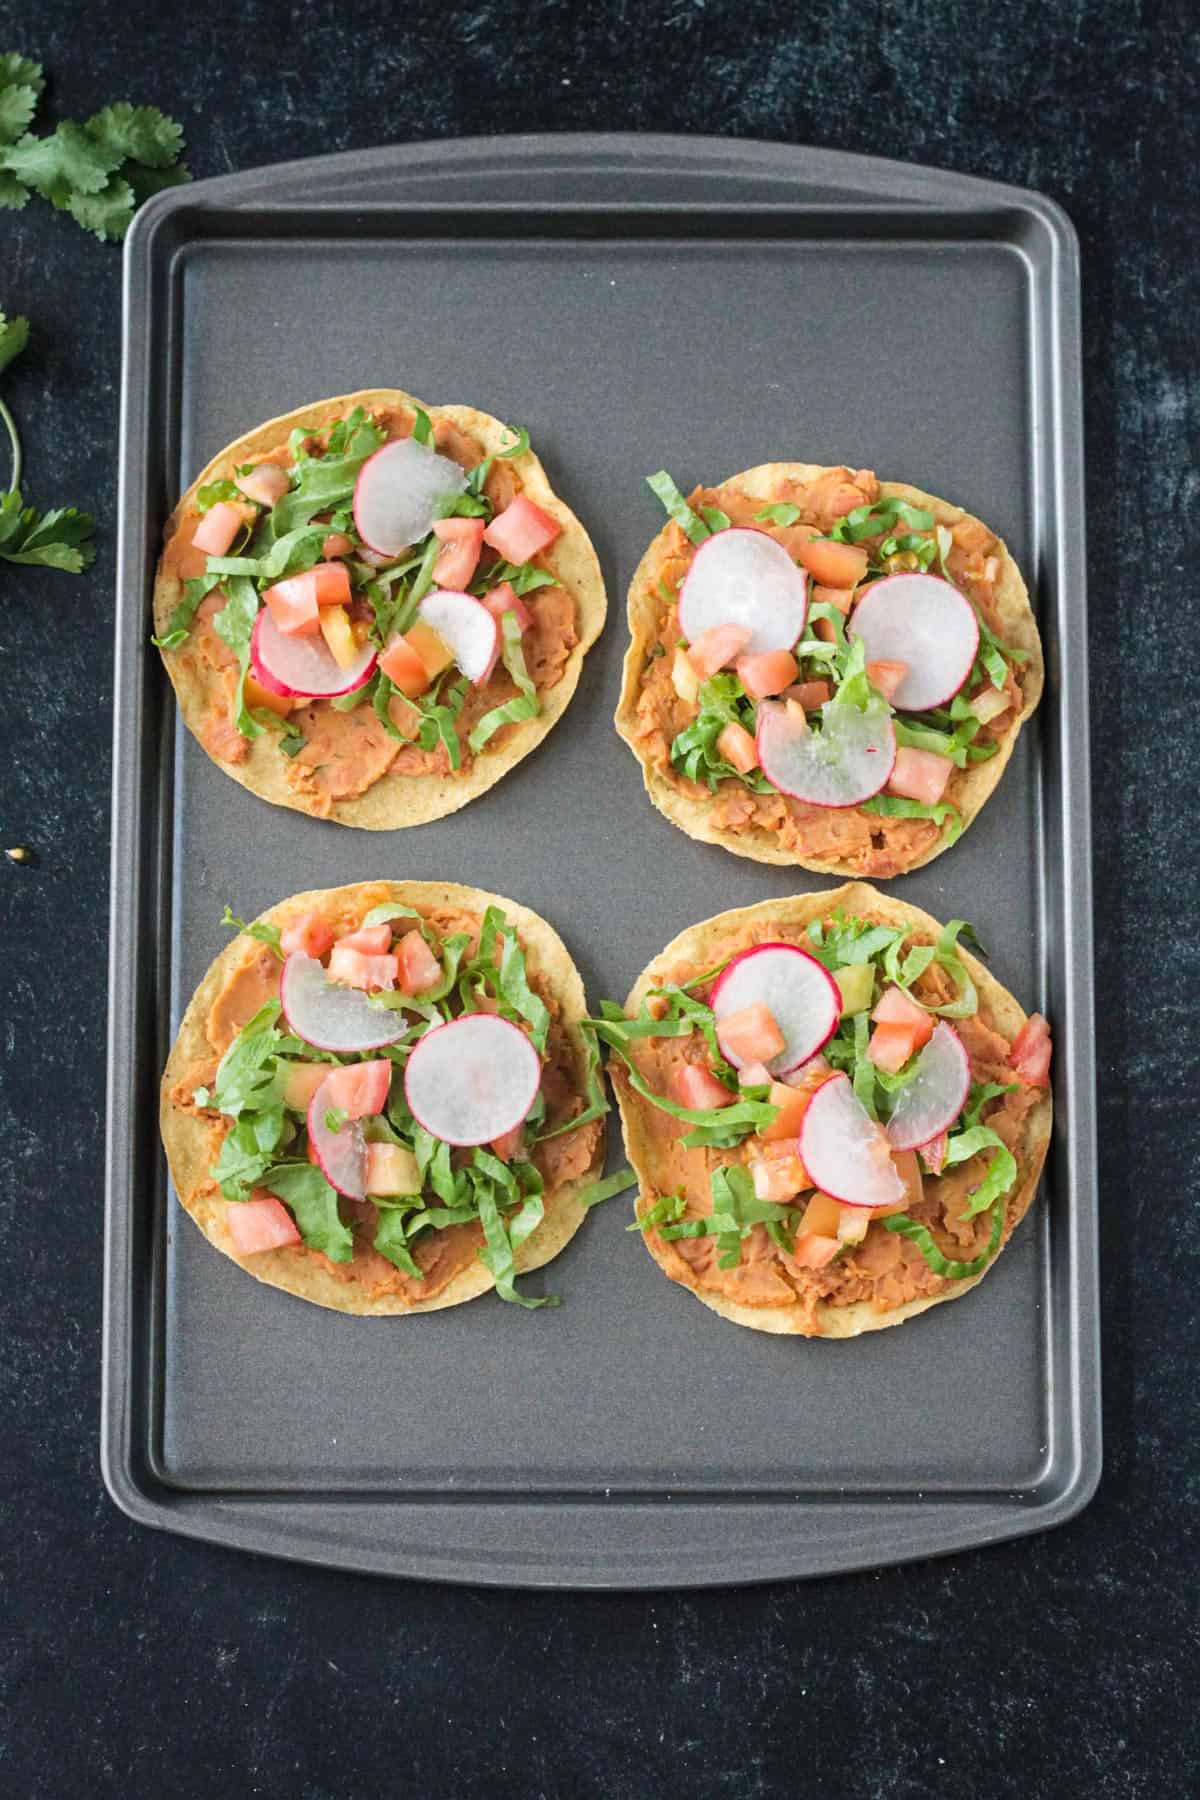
[849,574,979,713]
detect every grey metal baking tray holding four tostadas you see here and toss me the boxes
[103,135,1101,1588]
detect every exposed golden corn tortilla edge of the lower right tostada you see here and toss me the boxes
[613,882,1052,1337]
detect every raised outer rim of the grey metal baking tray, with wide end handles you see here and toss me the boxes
[101,133,1101,1589]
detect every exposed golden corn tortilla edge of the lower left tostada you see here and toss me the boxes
[158,882,604,1318]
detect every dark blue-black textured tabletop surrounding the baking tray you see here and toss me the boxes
[0,0,1200,1800]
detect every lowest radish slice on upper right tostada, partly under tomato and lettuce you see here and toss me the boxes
[754,700,896,806]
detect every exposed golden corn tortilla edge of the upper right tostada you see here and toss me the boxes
[615,463,1043,875]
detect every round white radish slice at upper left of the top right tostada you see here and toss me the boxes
[680,526,808,657]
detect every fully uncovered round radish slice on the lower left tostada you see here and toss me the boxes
[405,1013,542,1145]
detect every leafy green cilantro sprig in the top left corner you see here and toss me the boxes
[0,52,191,243]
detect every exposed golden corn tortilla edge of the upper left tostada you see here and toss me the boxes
[155,387,608,832]
